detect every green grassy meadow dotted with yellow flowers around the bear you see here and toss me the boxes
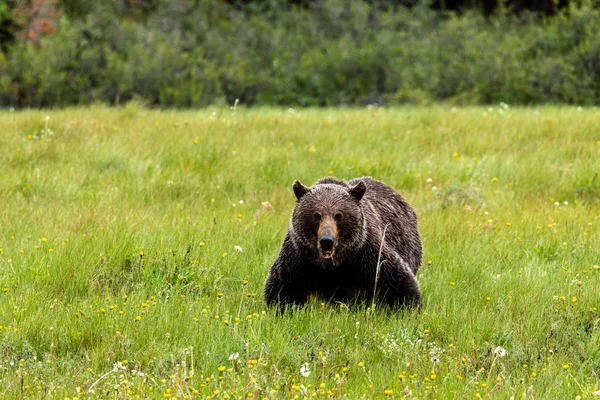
[0,104,600,399]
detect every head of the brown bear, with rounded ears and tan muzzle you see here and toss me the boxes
[290,179,367,269]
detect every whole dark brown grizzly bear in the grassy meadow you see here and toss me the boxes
[264,177,423,307]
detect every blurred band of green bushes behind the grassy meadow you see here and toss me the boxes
[0,0,600,107]
